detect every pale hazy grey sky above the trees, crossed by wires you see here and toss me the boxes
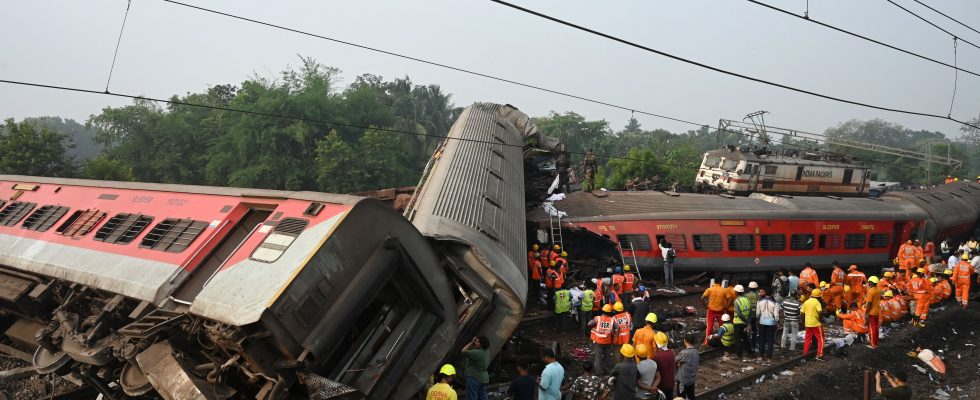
[0,0,980,138]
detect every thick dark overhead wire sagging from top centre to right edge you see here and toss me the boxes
[490,0,980,129]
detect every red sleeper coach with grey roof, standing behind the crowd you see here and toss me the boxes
[530,182,980,272]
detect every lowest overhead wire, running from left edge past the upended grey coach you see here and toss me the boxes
[0,79,699,169]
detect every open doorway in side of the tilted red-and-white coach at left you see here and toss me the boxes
[173,208,272,304]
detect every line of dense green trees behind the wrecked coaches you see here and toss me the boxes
[0,59,980,193]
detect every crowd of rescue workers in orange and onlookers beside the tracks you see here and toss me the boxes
[427,239,980,400]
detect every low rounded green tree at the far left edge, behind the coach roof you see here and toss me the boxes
[0,118,76,177]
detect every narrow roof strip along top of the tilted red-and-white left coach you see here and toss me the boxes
[0,175,364,204]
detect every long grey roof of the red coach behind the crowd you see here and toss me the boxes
[528,192,919,222]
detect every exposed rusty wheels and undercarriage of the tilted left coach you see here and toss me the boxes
[0,268,297,398]
